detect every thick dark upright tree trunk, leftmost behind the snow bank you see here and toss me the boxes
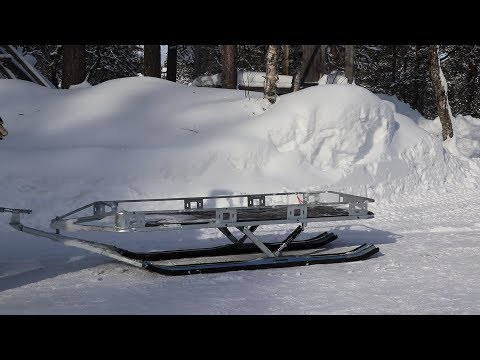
[62,45,85,89]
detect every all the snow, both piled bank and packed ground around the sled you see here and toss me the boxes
[0,77,480,314]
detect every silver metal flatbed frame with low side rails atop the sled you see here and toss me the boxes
[50,191,375,231]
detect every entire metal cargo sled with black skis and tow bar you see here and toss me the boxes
[0,191,379,275]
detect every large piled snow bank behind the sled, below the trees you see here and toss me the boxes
[0,77,478,226]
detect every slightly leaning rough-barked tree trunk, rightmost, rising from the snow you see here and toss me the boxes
[430,45,453,141]
